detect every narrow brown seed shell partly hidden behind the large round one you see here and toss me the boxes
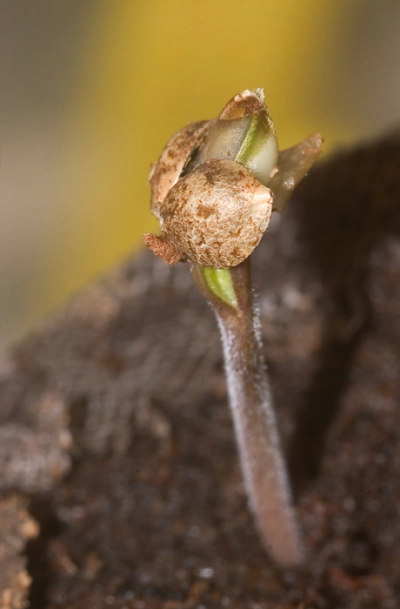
[149,121,213,218]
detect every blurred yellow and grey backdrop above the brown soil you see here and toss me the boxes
[0,0,400,348]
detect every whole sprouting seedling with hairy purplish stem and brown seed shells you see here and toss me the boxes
[143,89,322,566]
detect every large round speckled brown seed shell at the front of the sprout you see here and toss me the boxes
[160,160,273,268]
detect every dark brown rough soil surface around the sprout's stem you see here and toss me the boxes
[0,135,400,609]
